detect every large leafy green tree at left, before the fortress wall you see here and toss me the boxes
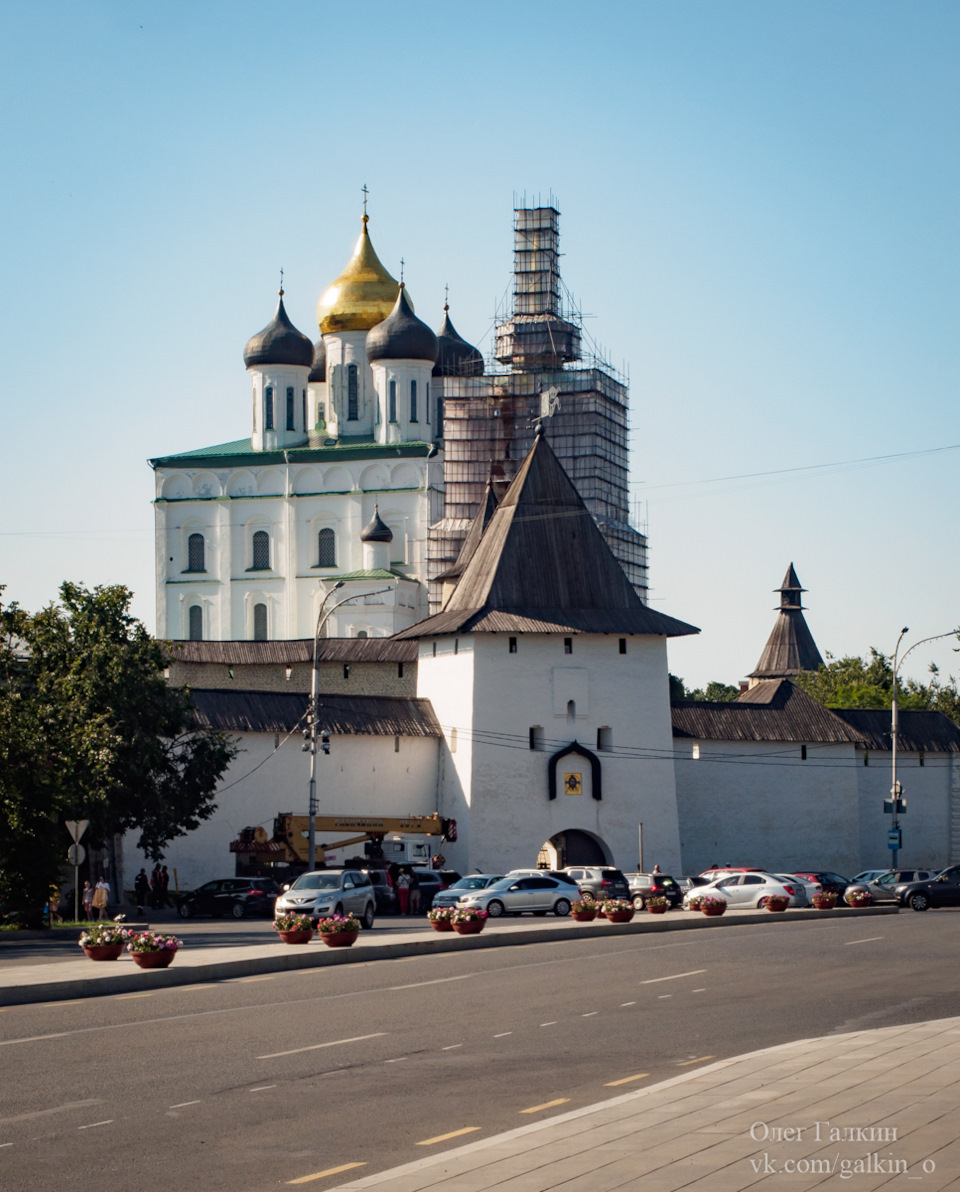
[0,583,236,918]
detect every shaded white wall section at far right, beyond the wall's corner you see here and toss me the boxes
[841,750,955,873]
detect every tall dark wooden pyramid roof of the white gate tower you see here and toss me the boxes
[395,430,700,640]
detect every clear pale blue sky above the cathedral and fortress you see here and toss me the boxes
[0,0,960,687]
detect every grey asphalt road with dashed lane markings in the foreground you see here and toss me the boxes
[0,911,960,1192]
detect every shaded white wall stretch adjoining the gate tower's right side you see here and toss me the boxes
[676,740,862,876]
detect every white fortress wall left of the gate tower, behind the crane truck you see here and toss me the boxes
[124,733,441,889]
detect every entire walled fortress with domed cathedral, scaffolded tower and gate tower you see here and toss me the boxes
[144,206,960,886]
